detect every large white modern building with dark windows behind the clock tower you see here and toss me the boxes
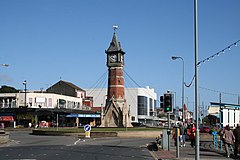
[85,86,158,125]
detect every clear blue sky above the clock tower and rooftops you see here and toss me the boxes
[0,0,240,110]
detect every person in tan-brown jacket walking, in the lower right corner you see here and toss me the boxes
[223,125,235,158]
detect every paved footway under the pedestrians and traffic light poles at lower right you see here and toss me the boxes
[150,140,240,160]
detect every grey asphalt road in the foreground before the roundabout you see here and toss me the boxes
[0,131,154,160]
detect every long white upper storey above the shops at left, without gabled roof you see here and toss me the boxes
[0,92,89,110]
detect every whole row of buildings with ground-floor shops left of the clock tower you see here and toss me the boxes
[0,80,101,127]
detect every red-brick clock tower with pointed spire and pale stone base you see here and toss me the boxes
[101,28,132,127]
